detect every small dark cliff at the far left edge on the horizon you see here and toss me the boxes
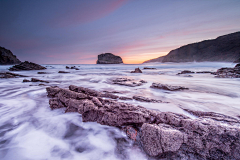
[0,47,21,65]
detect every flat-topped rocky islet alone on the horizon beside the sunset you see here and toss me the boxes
[97,53,123,64]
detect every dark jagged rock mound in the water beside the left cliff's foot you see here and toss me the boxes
[9,61,47,71]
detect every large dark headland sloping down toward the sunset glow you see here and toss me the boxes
[162,32,240,62]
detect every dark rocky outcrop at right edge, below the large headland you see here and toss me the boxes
[212,63,240,78]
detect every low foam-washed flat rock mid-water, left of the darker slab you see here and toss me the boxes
[111,78,147,87]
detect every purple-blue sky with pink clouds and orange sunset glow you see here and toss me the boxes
[0,0,240,64]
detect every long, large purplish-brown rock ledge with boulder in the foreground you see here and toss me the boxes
[47,85,240,160]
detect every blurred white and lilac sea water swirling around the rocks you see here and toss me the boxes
[0,62,240,160]
